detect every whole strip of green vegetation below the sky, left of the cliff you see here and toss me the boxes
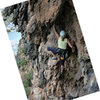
[17,47,33,97]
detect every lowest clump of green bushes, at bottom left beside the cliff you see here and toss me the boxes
[23,70,33,96]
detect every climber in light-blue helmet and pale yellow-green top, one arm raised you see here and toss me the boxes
[47,26,75,73]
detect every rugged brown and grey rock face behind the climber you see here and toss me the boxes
[2,0,99,100]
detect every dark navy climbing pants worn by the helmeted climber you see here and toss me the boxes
[47,47,66,66]
